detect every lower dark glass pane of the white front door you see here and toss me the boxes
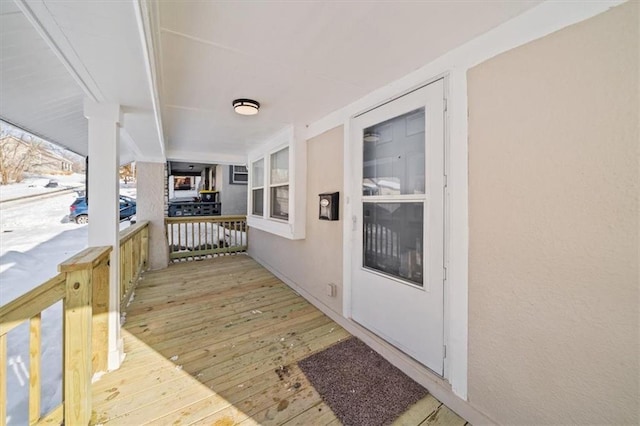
[362,202,424,286]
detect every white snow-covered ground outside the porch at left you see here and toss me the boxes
[0,179,136,425]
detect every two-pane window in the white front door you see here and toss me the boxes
[362,108,431,287]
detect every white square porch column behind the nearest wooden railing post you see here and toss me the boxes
[84,99,124,370]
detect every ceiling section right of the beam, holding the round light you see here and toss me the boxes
[155,0,539,158]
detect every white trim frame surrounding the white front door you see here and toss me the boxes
[342,71,468,390]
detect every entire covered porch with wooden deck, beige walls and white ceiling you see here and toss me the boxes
[0,0,640,426]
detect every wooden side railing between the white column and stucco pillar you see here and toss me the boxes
[120,221,149,310]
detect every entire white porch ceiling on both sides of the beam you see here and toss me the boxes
[0,0,540,163]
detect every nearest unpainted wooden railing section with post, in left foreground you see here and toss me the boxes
[0,247,111,425]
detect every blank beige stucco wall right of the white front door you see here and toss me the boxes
[468,1,640,424]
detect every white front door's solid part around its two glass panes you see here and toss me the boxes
[349,79,445,375]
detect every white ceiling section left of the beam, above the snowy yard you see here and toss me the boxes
[0,0,164,163]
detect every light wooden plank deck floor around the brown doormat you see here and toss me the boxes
[92,255,465,426]
